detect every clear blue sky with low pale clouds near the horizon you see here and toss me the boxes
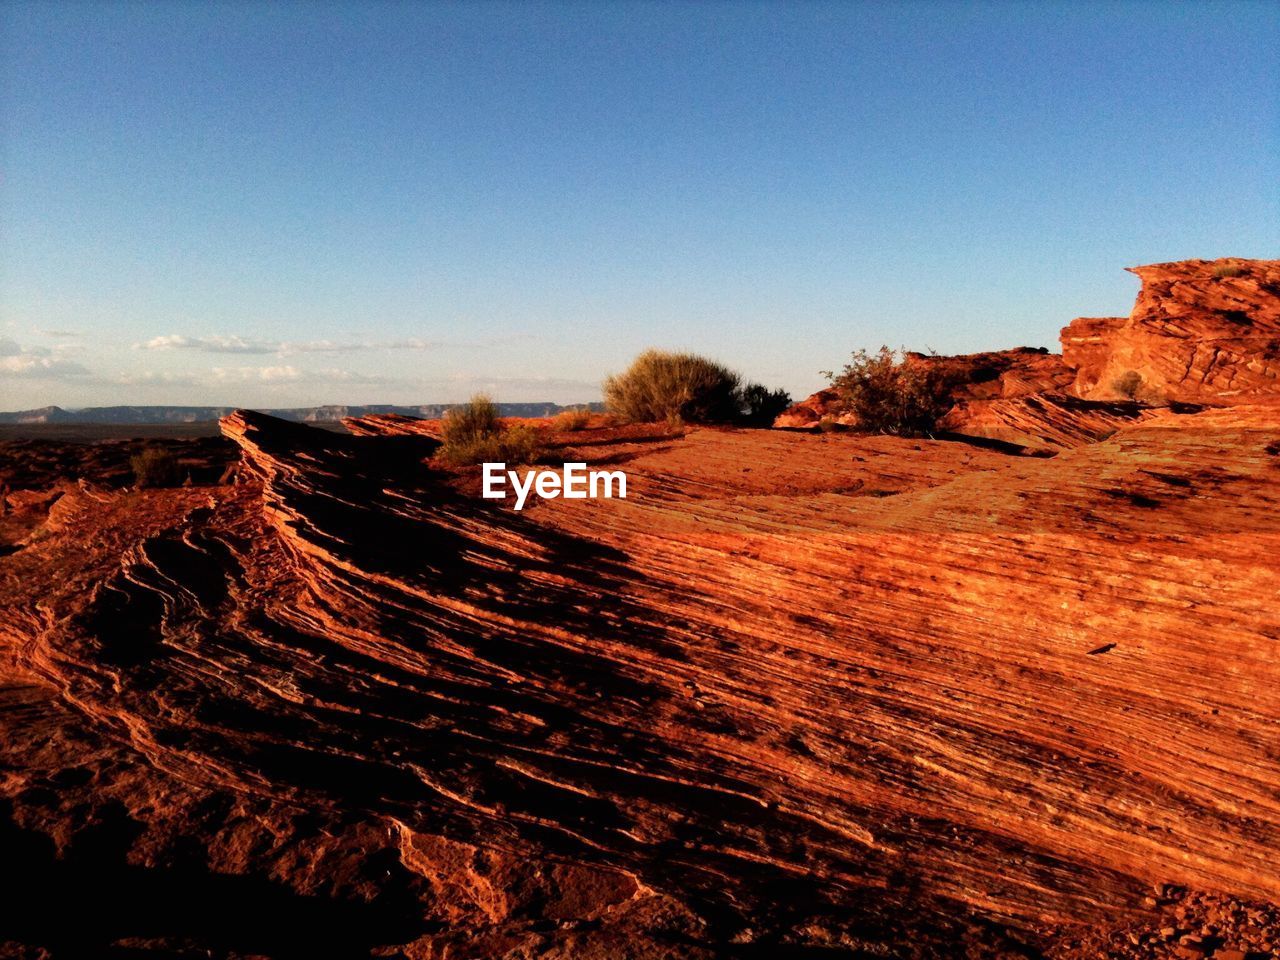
[0,0,1280,410]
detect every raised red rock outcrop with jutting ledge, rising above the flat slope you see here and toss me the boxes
[774,257,1280,435]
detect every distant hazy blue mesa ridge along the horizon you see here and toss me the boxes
[0,403,604,424]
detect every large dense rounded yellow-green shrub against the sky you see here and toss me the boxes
[604,349,742,424]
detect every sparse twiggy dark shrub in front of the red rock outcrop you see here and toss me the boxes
[824,347,954,436]
